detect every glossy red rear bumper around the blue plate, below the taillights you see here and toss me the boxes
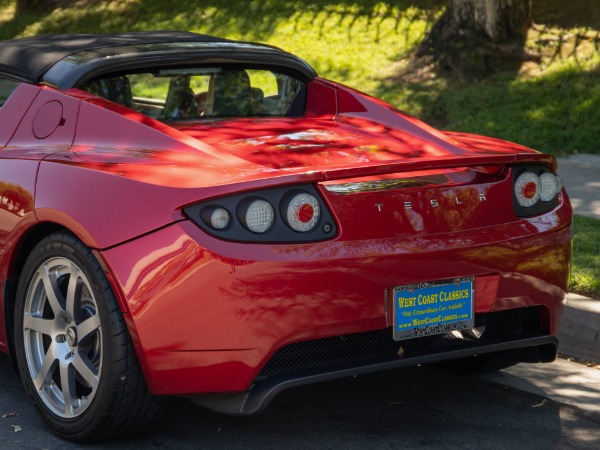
[102,207,571,398]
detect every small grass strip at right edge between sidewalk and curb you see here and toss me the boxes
[571,216,600,299]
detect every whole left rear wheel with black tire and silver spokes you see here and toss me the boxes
[15,232,163,442]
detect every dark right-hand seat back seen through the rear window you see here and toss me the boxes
[205,70,253,117]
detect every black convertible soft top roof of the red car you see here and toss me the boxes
[0,31,316,88]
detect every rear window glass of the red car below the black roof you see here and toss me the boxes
[81,67,306,122]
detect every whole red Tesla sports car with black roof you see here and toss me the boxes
[0,31,572,441]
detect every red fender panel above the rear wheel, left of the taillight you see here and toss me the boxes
[35,161,184,249]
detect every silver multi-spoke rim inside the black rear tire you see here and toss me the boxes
[23,258,102,418]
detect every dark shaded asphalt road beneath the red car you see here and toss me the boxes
[0,355,600,450]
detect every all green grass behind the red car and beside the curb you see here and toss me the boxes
[0,0,600,298]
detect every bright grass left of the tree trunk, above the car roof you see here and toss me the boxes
[0,0,441,96]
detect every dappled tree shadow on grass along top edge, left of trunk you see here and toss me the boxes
[0,0,443,40]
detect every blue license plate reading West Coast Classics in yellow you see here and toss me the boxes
[393,277,475,341]
